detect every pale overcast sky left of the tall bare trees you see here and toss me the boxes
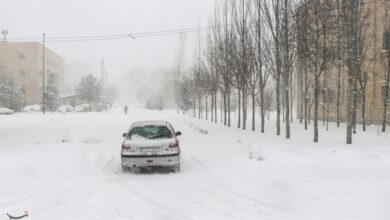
[0,0,214,81]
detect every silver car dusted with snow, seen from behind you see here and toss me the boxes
[121,121,181,172]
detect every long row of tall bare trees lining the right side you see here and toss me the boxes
[174,0,386,144]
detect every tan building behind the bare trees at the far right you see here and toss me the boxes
[296,0,390,124]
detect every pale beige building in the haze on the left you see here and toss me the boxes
[0,42,64,104]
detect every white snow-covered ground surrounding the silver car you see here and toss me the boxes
[0,108,390,220]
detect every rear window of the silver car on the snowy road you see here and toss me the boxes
[129,126,172,139]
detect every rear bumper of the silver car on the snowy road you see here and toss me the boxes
[121,153,180,167]
